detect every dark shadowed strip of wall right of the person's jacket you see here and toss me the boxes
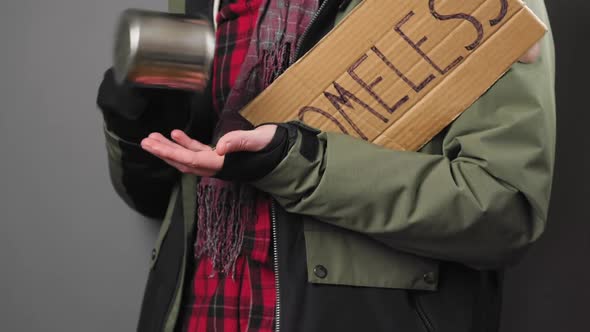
[501,0,590,332]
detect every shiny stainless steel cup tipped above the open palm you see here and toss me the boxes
[114,9,215,92]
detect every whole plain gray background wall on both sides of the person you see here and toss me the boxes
[0,0,590,332]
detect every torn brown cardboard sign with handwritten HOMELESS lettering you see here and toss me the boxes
[241,0,547,150]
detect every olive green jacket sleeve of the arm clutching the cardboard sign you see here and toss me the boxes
[254,0,555,269]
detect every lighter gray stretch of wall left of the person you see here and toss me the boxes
[0,0,166,332]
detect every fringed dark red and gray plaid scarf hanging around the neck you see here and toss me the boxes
[195,0,318,275]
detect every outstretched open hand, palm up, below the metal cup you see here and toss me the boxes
[141,125,277,176]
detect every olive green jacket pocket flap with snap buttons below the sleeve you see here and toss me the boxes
[304,218,439,291]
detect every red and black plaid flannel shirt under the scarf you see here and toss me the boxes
[181,0,276,332]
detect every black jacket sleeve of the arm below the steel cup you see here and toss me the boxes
[97,71,213,219]
